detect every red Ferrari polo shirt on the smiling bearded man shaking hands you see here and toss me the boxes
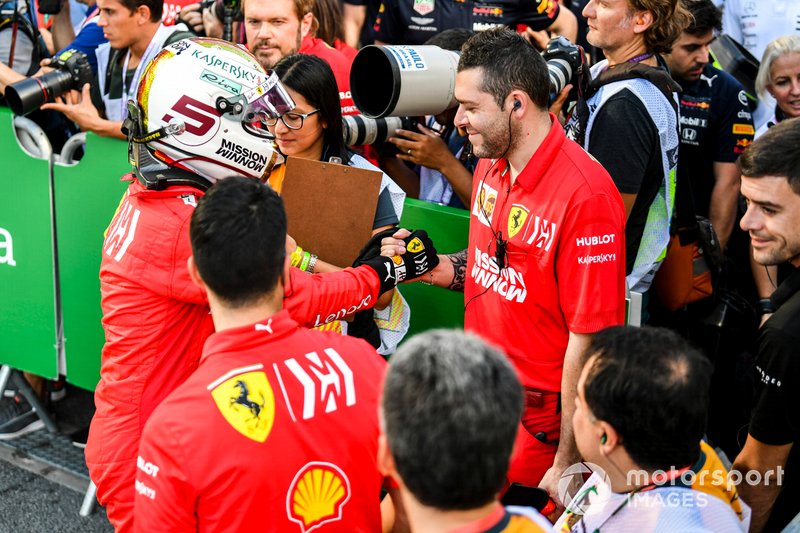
[464,115,625,391]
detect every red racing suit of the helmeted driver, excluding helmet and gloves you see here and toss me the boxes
[86,175,379,532]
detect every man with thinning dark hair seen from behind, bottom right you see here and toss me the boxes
[555,326,749,533]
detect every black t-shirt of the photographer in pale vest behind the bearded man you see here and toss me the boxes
[589,89,664,274]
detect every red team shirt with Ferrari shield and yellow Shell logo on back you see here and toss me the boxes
[135,311,386,533]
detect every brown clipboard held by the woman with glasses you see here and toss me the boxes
[281,157,382,267]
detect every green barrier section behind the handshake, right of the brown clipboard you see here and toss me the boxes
[400,198,469,338]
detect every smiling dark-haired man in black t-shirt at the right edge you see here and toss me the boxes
[734,119,800,531]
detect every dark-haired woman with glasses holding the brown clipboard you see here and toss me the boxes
[266,54,411,355]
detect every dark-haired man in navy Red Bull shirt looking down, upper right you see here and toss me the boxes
[664,0,755,249]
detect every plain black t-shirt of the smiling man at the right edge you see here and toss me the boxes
[750,268,800,531]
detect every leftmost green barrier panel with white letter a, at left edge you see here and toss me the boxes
[0,109,58,378]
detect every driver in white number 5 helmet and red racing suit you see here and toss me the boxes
[86,39,437,531]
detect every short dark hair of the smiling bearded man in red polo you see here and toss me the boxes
[458,28,550,111]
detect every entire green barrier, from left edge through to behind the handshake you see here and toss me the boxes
[0,108,469,390]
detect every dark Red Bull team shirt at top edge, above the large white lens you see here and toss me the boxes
[375,0,559,45]
